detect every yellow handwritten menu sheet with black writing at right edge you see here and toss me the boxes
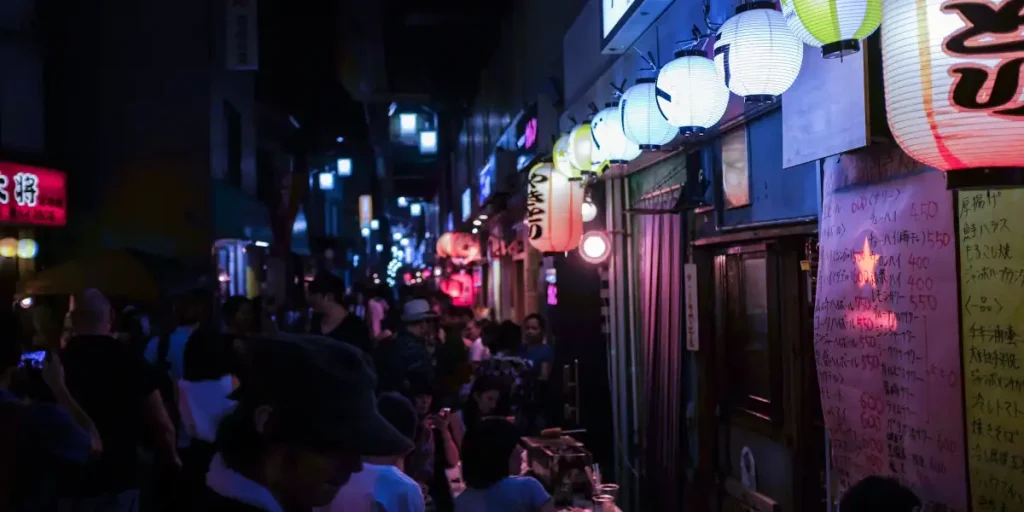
[957,189,1024,512]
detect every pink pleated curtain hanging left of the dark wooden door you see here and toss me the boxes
[637,214,686,510]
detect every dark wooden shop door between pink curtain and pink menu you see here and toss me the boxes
[694,236,825,512]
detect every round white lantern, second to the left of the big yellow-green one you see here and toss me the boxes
[657,50,729,136]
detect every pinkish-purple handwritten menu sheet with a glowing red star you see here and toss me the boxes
[814,171,967,512]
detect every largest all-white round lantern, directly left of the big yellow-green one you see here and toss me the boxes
[715,1,804,103]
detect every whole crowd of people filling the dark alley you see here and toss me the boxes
[0,272,554,512]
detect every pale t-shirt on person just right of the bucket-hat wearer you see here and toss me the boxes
[318,463,426,512]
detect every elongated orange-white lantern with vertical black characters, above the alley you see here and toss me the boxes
[526,163,584,253]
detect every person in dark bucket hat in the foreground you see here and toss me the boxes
[196,335,413,512]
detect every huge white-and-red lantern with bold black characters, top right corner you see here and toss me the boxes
[882,0,1024,171]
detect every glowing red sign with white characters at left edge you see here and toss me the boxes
[0,162,68,226]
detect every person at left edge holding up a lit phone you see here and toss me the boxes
[0,319,102,511]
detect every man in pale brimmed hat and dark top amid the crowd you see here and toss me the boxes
[374,299,437,392]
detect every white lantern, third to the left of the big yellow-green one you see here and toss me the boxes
[618,78,677,150]
